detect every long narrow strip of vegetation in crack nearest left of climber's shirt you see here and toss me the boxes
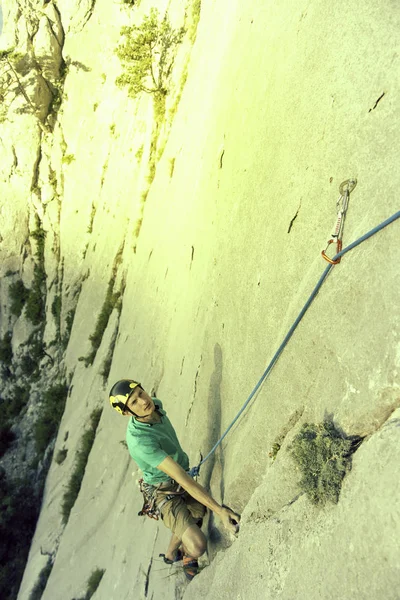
[61,408,103,523]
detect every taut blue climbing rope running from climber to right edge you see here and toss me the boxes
[189,211,400,477]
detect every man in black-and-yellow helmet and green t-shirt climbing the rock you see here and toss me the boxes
[110,379,240,580]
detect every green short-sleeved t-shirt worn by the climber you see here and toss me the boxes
[126,398,189,485]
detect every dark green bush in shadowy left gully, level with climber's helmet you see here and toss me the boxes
[33,383,68,458]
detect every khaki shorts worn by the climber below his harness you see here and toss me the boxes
[156,484,207,540]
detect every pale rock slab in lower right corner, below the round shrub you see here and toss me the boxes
[184,409,400,600]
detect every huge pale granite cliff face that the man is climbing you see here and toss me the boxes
[0,0,400,600]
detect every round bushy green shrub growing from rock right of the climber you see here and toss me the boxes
[290,421,354,505]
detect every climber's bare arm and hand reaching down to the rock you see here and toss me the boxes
[157,456,240,533]
